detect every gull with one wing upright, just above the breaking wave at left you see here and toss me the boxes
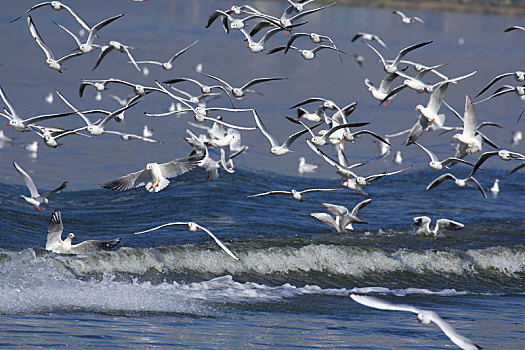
[46,210,120,254]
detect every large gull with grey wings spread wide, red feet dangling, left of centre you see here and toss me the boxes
[102,152,202,192]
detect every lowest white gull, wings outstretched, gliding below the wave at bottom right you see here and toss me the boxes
[350,294,481,350]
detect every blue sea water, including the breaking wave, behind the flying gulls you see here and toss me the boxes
[0,1,525,349]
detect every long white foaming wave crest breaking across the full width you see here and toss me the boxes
[0,244,525,278]
